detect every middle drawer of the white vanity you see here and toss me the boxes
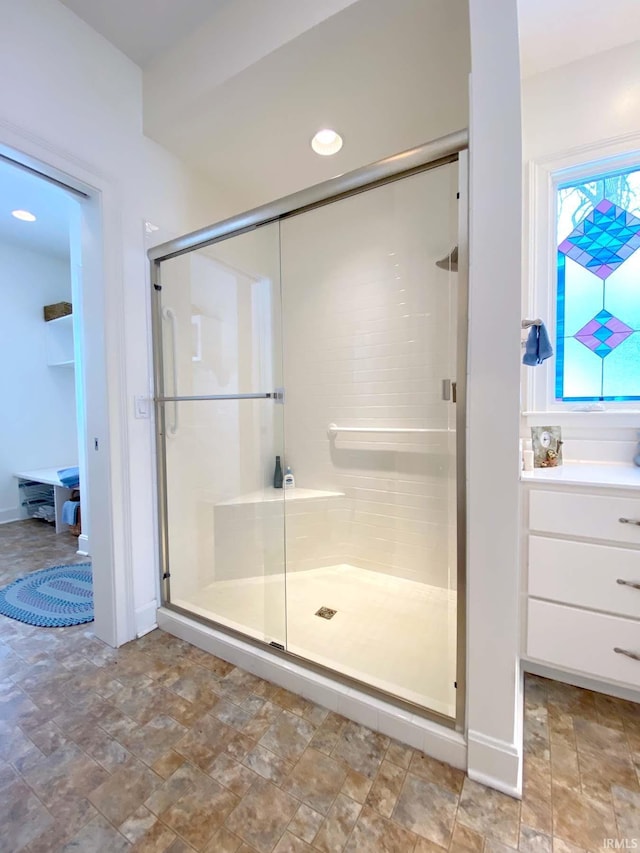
[528,535,640,619]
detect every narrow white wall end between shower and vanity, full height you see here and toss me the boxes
[467,0,523,796]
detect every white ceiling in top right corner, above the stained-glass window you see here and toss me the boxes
[518,0,640,77]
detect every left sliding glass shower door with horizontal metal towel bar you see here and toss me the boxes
[156,223,286,647]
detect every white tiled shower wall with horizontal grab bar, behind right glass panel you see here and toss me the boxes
[281,164,457,587]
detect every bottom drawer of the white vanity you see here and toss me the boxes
[527,599,640,687]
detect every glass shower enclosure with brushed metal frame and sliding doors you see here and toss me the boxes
[149,133,467,726]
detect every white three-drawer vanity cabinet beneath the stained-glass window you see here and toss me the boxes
[522,465,640,698]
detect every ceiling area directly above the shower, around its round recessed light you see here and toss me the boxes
[145,0,470,207]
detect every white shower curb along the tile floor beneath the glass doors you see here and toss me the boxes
[157,608,467,770]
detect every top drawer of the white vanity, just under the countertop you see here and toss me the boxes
[529,489,640,546]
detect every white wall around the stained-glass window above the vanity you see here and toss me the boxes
[521,42,640,462]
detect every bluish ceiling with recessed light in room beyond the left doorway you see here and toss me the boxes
[0,160,76,258]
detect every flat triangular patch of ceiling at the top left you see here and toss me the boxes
[56,0,231,68]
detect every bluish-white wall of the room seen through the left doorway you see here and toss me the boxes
[0,242,78,521]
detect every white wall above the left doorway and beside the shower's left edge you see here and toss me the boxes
[0,0,235,643]
